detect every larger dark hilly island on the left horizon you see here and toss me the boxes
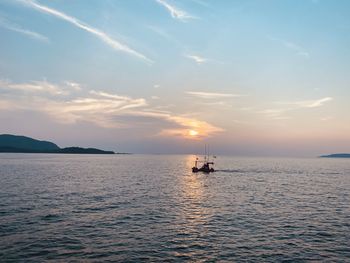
[0,134,115,154]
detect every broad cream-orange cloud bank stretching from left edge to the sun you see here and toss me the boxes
[0,80,222,139]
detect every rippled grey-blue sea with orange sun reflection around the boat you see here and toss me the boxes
[0,153,350,262]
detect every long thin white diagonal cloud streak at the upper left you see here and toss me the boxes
[17,0,153,63]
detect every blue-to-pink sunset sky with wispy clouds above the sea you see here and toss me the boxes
[0,0,350,156]
